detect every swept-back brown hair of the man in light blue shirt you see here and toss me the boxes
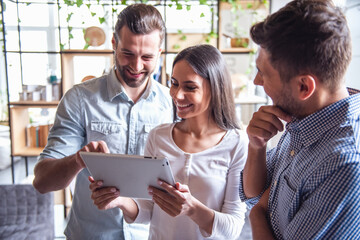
[114,3,165,45]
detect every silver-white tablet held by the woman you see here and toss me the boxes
[80,152,175,199]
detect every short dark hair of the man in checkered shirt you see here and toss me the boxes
[250,0,351,90]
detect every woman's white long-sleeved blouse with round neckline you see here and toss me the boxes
[134,123,248,240]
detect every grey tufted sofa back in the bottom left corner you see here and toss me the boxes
[0,184,55,240]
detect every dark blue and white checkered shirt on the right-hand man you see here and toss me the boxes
[240,91,360,239]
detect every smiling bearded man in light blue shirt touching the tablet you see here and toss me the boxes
[33,4,174,240]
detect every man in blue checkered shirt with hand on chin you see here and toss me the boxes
[240,0,360,239]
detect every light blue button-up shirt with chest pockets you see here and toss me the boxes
[40,69,173,240]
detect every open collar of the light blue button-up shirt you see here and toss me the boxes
[107,67,156,101]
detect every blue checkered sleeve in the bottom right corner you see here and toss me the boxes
[283,153,360,239]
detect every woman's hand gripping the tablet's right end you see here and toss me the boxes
[149,180,196,217]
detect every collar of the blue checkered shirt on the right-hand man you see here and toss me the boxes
[286,89,360,146]
